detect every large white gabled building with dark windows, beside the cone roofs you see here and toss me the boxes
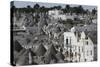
[64,29,94,62]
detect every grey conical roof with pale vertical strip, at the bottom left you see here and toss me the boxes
[16,49,35,65]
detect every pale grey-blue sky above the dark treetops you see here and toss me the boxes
[11,1,97,11]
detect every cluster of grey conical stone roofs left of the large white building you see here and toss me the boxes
[14,40,64,65]
